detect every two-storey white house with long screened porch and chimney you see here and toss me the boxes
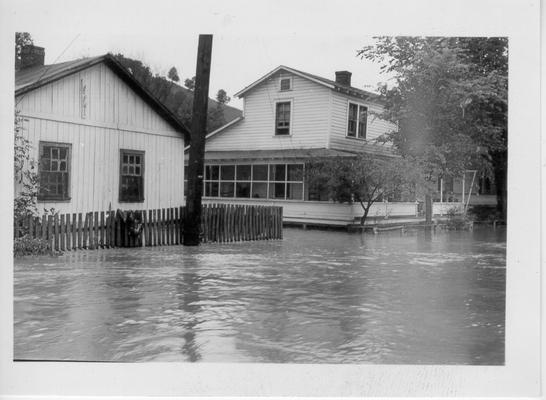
[187,66,492,225]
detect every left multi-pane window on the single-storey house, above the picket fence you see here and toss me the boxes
[38,142,72,201]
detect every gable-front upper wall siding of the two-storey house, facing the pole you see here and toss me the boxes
[206,73,330,151]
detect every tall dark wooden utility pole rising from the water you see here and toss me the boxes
[184,35,212,246]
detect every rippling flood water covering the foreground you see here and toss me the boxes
[14,228,506,365]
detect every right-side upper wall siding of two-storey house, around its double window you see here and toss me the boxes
[330,92,396,151]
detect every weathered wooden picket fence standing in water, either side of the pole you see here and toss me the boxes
[14,204,282,251]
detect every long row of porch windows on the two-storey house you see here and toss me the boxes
[204,164,303,200]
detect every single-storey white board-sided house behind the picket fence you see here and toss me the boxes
[15,46,188,213]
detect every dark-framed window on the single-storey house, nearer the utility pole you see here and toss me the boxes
[119,150,144,203]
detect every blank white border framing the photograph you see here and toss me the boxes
[0,0,544,398]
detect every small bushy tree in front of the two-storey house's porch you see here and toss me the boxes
[306,153,422,225]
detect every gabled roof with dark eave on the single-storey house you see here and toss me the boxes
[15,54,190,141]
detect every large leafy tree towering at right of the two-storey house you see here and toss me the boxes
[358,37,508,219]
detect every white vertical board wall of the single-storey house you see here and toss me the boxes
[16,60,184,213]
